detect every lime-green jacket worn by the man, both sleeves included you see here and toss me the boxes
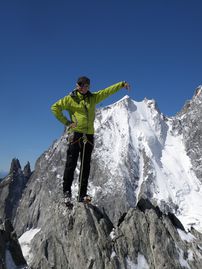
[51,81,124,134]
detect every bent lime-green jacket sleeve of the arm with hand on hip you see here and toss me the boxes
[51,96,71,126]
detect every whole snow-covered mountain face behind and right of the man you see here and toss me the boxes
[91,96,202,229]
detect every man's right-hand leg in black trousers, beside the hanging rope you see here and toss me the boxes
[79,135,94,200]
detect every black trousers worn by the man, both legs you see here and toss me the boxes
[63,132,94,198]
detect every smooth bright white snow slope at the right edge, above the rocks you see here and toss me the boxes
[155,121,202,213]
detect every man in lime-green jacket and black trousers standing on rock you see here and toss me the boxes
[51,77,130,205]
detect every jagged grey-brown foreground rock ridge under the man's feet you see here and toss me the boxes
[8,199,202,269]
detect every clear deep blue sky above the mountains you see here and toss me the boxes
[0,0,202,171]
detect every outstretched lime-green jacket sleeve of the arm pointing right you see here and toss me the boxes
[94,81,125,104]
